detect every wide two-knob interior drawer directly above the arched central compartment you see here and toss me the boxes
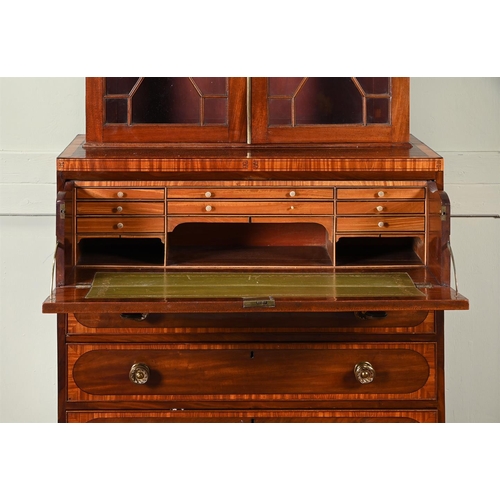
[168,200,333,215]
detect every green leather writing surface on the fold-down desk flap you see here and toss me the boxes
[87,272,423,299]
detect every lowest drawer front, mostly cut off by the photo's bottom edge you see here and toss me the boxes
[66,410,438,423]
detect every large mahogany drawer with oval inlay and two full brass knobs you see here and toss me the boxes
[68,343,436,401]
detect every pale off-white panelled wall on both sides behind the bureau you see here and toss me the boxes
[0,78,500,422]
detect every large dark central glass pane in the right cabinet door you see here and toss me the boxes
[295,77,363,125]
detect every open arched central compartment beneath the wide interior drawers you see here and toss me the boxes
[167,219,333,269]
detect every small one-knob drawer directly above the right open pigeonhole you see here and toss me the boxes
[337,216,425,232]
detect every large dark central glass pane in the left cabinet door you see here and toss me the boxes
[132,77,201,125]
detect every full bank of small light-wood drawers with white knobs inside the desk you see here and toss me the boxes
[77,188,425,233]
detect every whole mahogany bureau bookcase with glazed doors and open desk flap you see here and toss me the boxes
[43,77,468,422]
